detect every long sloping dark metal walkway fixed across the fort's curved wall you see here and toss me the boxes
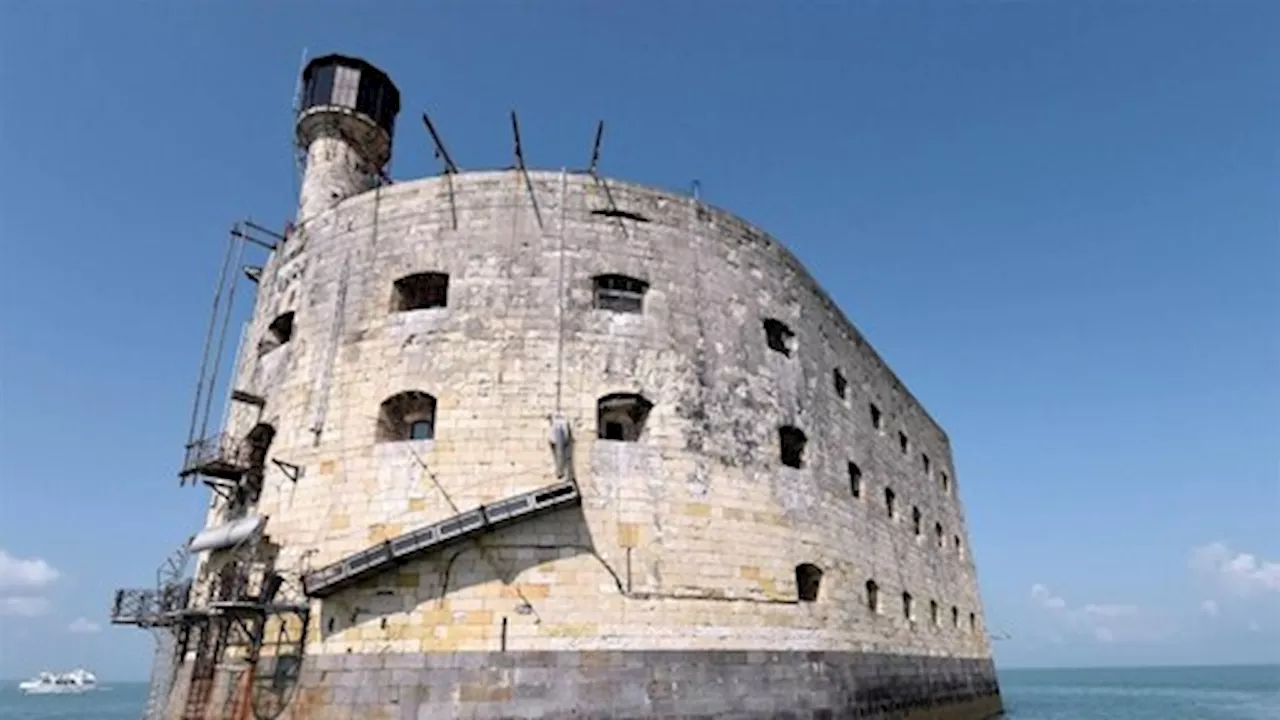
[302,482,582,597]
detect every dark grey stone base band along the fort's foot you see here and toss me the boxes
[170,651,1001,720]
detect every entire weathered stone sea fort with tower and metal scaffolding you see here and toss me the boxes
[113,55,1001,720]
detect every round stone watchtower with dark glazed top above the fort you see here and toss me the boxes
[296,55,399,225]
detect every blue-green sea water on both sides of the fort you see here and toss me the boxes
[0,665,1280,720]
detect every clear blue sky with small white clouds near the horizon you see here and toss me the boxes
[0,0,1280,678]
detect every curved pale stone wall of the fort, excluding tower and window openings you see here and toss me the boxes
[177,166,998,717]
